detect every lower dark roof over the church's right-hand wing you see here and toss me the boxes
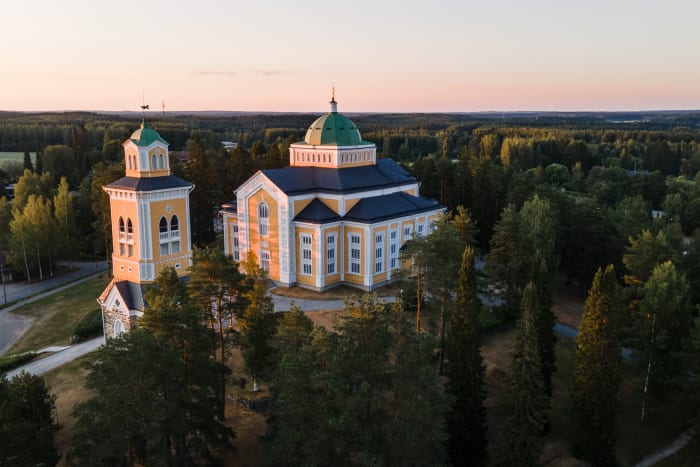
[343,192,445,223]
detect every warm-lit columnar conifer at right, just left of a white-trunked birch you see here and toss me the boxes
[571,266,620,466]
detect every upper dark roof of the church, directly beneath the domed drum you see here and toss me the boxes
[262,159,416,195]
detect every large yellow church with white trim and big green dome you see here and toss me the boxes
[221,98,445,291]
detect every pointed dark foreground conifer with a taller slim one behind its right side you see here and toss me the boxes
[496,282,549,466]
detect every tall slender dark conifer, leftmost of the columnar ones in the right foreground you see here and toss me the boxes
[446,246,487,466]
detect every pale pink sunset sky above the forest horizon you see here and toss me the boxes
[0,0,700,112]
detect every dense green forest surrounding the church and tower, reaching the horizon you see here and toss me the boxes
[0,112,700,466]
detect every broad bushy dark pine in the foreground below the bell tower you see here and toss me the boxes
[70,284,234,465]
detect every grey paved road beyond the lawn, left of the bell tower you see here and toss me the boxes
[0,262,106,355]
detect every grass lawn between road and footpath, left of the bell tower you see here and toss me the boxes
[6,277,109,355]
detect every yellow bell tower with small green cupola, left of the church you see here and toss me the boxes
[98,120,194,337]
